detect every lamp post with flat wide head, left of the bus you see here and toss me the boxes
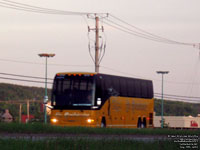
[38,53,55,123]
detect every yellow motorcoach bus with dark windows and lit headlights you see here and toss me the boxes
[50,72,154,128]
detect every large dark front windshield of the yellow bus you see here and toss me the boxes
[52,75,95,107]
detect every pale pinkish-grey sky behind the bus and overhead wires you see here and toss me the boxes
[0,0,200,102]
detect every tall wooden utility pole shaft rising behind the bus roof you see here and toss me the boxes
[95,16,99,73]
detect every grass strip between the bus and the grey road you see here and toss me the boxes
[0,123,200,135]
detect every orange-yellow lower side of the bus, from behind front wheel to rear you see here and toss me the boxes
[106,97,153,128]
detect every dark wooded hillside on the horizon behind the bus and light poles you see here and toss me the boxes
[0,83,200,121]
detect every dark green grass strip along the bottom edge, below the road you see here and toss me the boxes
[0,139,182,150]
